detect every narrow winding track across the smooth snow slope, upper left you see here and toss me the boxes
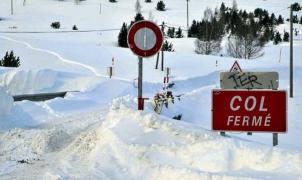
[0,36,105,77]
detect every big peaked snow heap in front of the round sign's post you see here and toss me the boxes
[44,97,302,179]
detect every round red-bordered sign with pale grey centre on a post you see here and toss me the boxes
[128,20,164,57]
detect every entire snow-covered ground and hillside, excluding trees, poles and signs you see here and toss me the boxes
[0,0,302,179]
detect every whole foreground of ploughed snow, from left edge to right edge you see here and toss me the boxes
[0,96,302,179]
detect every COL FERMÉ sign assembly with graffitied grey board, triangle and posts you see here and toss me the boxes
[219,61,287,146]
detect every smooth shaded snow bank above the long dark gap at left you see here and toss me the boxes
[0,69,101,95]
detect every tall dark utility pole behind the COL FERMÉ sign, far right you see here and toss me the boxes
[289,5,294,98]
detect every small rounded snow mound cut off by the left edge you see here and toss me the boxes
[0,87,14,116]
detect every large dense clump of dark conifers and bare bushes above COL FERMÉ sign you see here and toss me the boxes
[188,1,287,59]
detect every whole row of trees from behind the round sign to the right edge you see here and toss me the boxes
[118,0,302,59]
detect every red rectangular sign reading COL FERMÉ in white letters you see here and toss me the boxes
[212,90,287,133]
